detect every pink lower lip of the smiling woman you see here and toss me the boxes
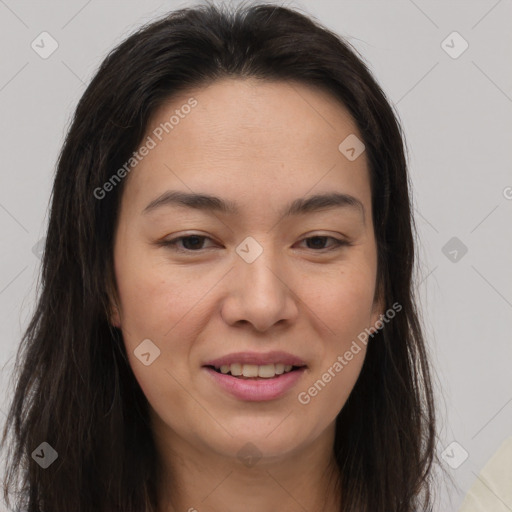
[203,367,306,402]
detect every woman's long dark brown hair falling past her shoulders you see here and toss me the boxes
[3,4,436,512]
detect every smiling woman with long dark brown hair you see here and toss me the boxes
[0,4,436,512]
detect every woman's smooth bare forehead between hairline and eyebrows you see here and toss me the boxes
[119,79,368,216]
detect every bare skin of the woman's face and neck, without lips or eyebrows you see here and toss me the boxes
[111,79,383,512]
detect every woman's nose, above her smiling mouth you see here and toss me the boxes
[222,244,299,332]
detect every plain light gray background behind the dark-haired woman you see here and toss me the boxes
[0,0,512,512]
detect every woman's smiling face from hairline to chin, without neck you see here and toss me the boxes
[112,80,382,459]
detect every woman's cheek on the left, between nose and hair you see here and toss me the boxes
[116,247,218,390]
